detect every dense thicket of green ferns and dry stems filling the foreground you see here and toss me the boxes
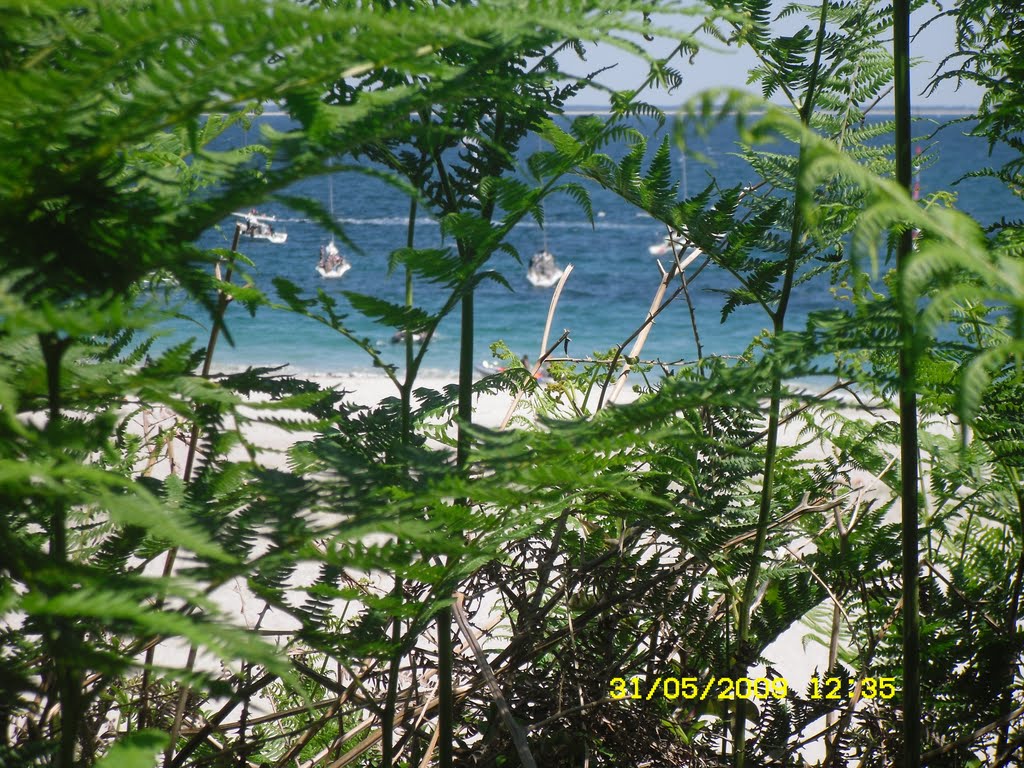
[0,0,1024,768]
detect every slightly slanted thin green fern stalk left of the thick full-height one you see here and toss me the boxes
[732,0,828,768]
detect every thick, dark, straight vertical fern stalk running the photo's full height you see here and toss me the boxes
[893,0,922,768]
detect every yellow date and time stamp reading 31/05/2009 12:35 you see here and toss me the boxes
[609,677,896,701]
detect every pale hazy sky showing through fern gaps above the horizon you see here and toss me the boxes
[561,3,981,108]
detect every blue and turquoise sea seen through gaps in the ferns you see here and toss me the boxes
[163,109,1022,374]
